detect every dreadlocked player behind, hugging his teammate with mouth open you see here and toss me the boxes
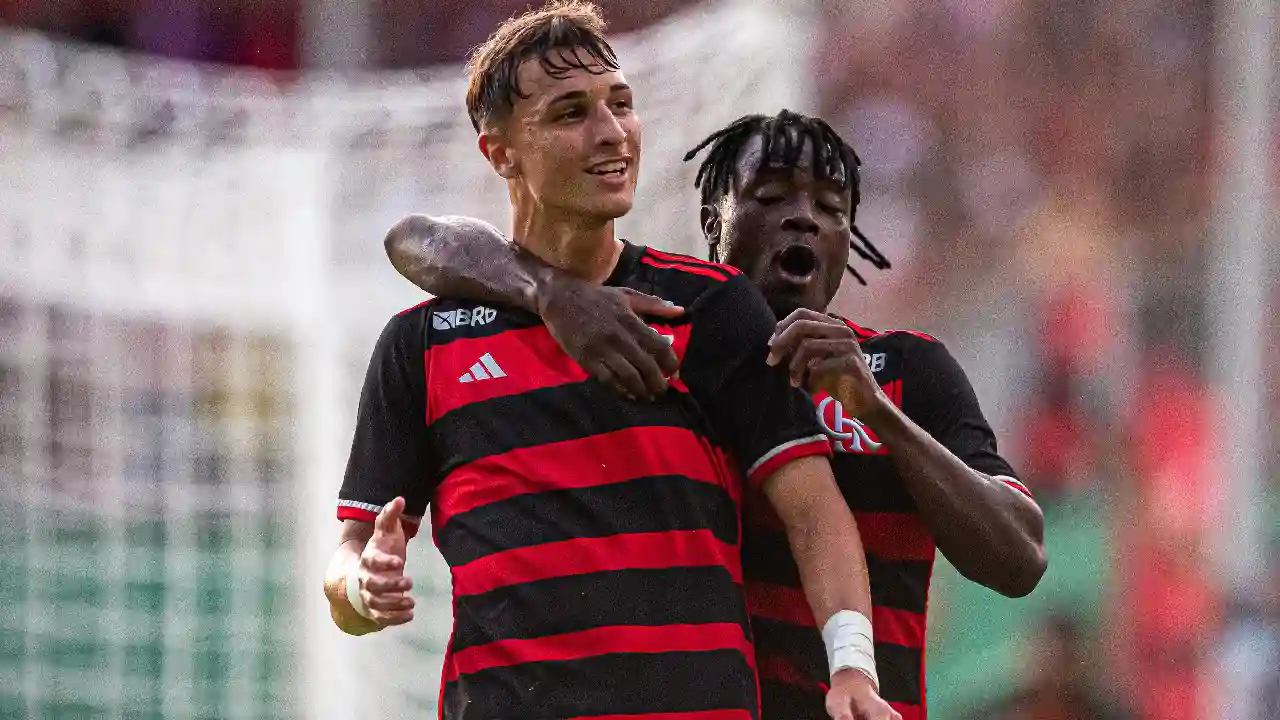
[387,110,1046,720]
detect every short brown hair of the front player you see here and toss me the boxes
[467,0,618,132]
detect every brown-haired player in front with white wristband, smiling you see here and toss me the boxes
[325,1,897,720]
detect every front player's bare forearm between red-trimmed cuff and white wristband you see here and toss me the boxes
[765,457,872,620]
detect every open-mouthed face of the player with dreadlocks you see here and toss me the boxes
[703,135,854,318]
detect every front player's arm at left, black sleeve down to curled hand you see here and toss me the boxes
[324,309,431,635]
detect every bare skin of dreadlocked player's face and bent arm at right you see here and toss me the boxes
[703,137,1047,597]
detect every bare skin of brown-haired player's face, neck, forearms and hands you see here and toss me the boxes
[326,50,899,720]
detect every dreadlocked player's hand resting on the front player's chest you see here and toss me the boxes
[538,275,685,400]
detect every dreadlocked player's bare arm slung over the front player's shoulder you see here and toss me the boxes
[384,215,682,398]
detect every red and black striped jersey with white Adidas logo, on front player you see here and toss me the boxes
[338,243,831,720]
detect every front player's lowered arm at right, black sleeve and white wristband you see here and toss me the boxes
[681,275,891,717]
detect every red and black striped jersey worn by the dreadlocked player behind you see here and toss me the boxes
[742,318,1029,720]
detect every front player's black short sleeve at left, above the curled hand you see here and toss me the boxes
[338,304,431,537]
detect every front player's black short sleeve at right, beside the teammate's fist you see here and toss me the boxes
[680,275,831,486]
